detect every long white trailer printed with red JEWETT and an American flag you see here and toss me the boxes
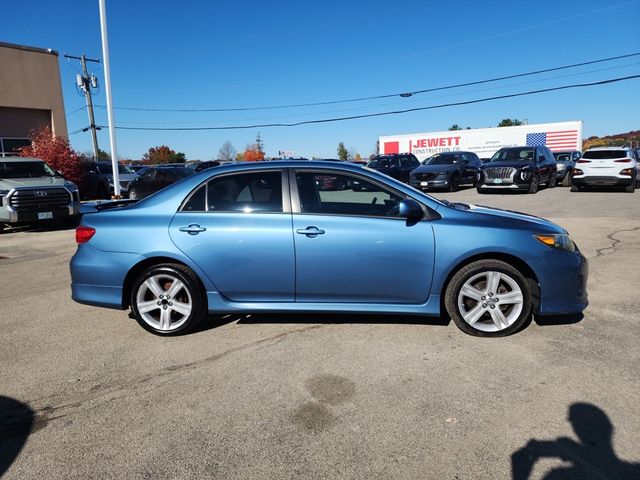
[380,121,582,161]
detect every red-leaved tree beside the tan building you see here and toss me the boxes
[19,127,84,185]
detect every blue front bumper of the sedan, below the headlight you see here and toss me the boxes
[528,248,589,315]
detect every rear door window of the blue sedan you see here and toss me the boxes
[207,171,282,213]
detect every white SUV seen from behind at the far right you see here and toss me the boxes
[571,147,640,193]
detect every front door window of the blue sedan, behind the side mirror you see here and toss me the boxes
[296,172,404,218]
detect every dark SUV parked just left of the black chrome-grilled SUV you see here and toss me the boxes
[409,152,481,192]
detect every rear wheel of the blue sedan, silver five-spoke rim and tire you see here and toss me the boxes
[131,263,206,335]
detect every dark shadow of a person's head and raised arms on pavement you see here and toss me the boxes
[511,403,640,480]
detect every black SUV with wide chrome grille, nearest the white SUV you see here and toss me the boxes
[476,147,558,193]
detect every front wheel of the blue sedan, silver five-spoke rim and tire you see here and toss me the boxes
[445,259,531,337]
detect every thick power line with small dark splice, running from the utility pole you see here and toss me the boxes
[96,52,640,113]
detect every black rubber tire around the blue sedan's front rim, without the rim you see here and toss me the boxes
[444,259,532,337]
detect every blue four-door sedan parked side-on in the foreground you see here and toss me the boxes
[71,161,588,336]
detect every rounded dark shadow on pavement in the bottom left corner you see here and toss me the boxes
[0,395,35,477]
